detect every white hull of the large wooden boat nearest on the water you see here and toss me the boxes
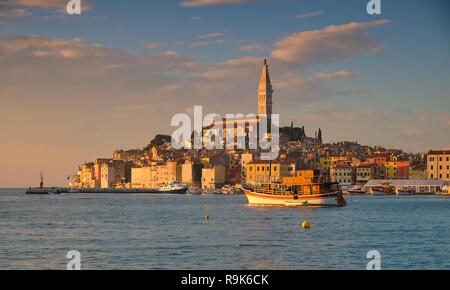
[243,189,345,207]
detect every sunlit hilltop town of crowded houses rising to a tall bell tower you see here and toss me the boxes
[71,60,450,189]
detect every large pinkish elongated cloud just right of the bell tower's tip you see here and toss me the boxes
[271,20,391,66]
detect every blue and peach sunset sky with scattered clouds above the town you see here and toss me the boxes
[0,0,450,187]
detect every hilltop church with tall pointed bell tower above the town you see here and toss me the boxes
[202,59,278,149]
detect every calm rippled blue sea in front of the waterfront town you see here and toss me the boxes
[0,189,450,270]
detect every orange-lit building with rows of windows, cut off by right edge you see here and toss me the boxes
[427,150,450,181]
